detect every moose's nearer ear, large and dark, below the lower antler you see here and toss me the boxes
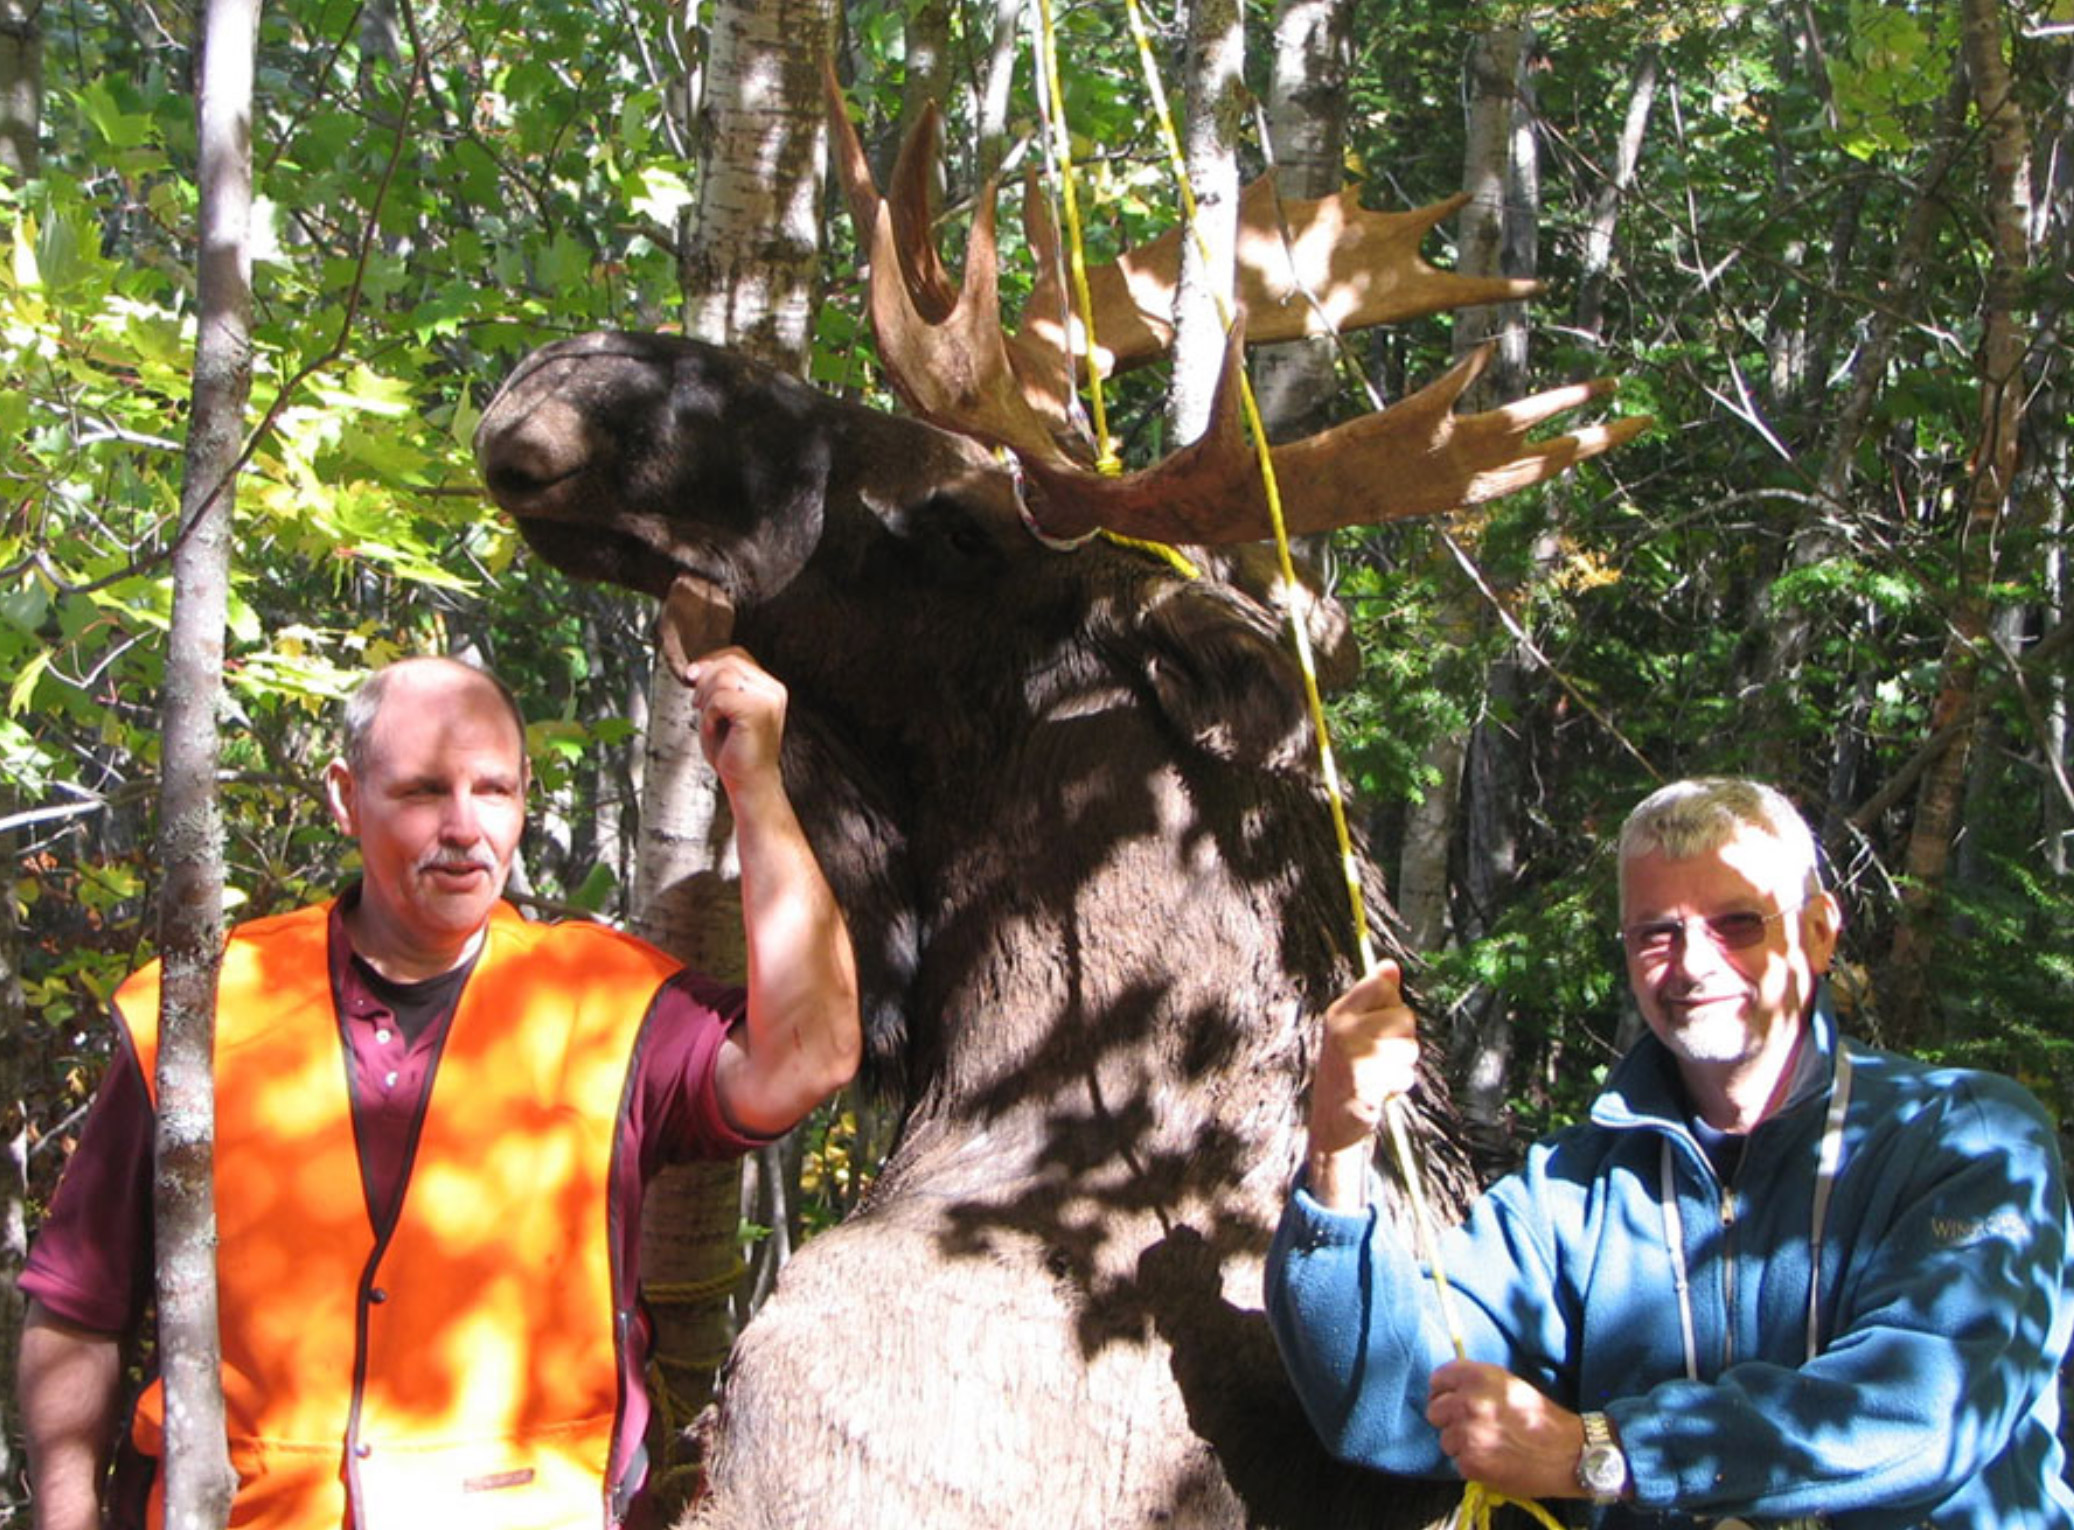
[1141,580,1311,769]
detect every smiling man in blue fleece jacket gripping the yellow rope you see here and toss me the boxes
[1267,780,2074,1530]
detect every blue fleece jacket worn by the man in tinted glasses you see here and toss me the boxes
[1267,1005,2074,1530]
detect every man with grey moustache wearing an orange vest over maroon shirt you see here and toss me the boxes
[19,649,861,1530]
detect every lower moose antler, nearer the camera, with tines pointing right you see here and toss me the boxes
[1031,346,1651,543]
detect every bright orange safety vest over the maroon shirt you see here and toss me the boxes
[116,904,676,1530]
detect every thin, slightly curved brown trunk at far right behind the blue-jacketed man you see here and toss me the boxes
[1887,0,2030,1045]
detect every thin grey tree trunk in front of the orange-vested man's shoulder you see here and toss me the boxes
[156,0,259,1530]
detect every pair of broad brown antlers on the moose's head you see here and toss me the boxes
[823,70,1649,543]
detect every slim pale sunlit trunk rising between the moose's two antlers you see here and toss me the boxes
[1168,0,1246,444]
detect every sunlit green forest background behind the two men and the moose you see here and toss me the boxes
[0,0,2074,1500]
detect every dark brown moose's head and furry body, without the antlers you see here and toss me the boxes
[477,336,1466,1530]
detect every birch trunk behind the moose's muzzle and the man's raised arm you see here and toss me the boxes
[633,0,836,1515]
